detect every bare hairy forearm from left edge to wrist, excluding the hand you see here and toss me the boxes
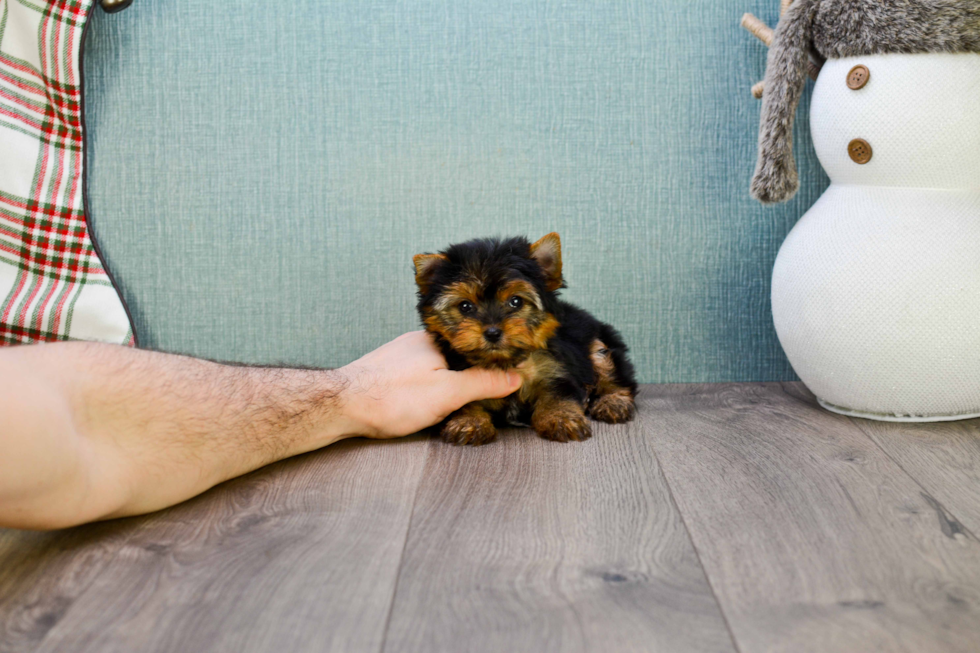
[0,343,363,528]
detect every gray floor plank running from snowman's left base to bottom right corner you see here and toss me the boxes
[641,384,980,653]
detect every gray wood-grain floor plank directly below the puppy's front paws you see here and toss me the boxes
[384,404,734,653]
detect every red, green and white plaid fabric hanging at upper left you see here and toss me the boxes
[0,0,134,345]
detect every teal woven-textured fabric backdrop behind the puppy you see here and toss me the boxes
[84,0,827,382]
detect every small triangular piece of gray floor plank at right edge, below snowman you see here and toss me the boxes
[851,418,980,536]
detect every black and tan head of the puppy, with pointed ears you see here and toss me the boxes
[413,233,565,368]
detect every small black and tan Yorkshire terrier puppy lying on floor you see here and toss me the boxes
[414,233,636,445]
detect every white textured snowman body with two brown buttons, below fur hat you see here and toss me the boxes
[753,0,980,421]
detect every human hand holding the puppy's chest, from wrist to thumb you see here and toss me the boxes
[337,331,521,438]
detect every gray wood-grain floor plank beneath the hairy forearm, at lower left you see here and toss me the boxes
[0,438,428,653]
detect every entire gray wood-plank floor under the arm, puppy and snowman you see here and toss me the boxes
[0,384,980,653]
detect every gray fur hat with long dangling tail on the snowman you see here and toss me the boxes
[752,0,980,204]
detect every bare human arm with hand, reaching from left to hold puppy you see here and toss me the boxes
[0,332,520,529]
